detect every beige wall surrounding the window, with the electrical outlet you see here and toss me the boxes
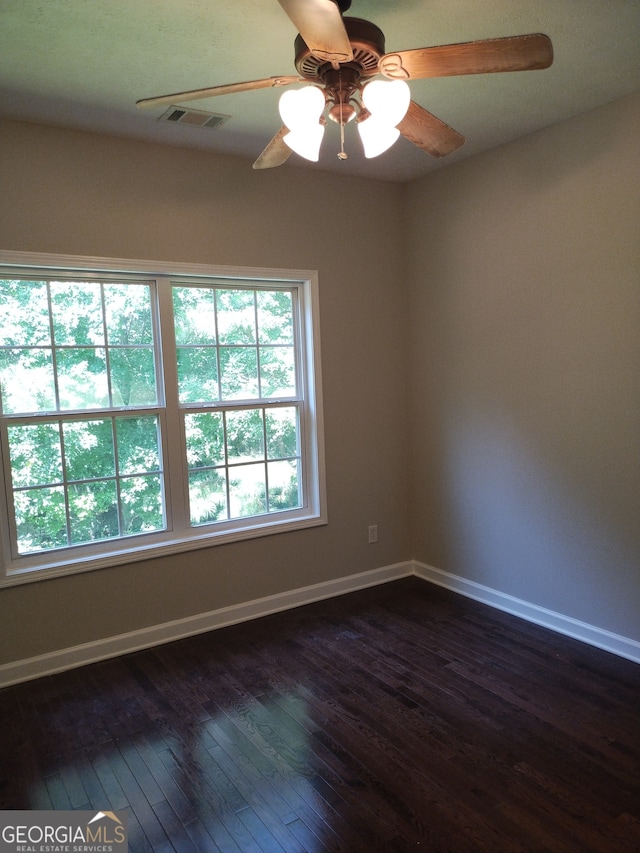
[0,122,411,662]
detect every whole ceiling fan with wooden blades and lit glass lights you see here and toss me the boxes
[137,0,553,169]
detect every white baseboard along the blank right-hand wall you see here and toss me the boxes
[413,561,640,663]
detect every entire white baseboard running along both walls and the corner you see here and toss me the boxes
[0,561,640,687]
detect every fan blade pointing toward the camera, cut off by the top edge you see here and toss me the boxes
[278,0,353,63]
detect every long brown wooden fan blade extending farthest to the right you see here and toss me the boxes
[379,33,553,80]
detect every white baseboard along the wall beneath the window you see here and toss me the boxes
[0,562,413,687]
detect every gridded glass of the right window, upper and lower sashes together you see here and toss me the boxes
[172,285,302,525]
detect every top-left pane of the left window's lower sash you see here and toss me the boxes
[7,424,62,489]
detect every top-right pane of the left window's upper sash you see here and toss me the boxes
[104,284,153,346]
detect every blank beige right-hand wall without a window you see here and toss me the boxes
[406,95,640,640]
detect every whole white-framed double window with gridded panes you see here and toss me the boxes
[0,253,325,583]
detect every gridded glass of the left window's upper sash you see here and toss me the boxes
[0,278,158,415]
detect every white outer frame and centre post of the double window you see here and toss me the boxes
[0,250,327,587]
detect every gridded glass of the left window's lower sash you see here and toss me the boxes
[7,415,166,555]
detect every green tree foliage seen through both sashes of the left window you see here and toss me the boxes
[0,280,165,553]
